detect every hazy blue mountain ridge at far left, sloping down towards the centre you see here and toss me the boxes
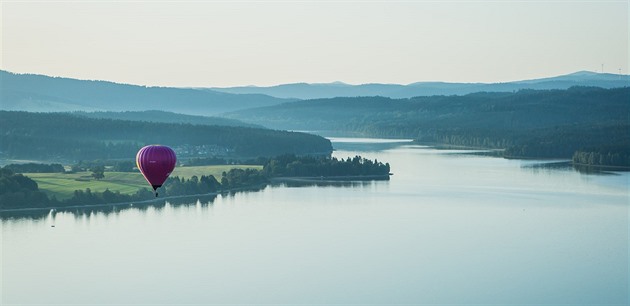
[0,70,288,115]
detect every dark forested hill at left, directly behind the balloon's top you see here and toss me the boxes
[0,111,332,160]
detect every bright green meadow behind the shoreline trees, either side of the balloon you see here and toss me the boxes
[24,165,262,200]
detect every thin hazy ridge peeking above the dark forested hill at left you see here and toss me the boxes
[71,110,262,128]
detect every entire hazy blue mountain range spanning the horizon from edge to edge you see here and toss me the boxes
[0,70,630,116]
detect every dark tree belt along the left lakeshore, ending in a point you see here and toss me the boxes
[0,155,390,210]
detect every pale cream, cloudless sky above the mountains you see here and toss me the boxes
[0,0,630,87]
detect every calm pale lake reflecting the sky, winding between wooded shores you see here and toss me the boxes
[1,138,630,305]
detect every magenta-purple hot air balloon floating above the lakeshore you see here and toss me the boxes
[136,145,177,197]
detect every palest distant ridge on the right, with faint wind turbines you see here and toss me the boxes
[211,71,630,99]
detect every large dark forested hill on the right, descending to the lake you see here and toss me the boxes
[230,87,630,165]
